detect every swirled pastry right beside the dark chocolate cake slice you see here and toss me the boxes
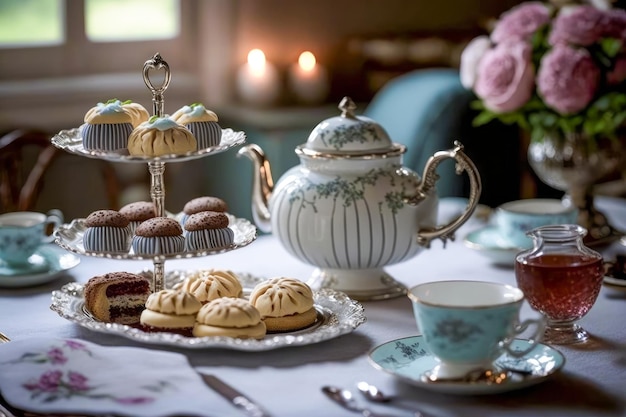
[139,290,202,336]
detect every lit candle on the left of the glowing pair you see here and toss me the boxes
[237,49,280,106]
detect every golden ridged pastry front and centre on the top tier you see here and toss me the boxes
[128,116,198,157]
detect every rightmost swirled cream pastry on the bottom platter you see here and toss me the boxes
[250,277,317,332]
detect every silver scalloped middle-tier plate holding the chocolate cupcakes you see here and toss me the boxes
[54,213,257,260]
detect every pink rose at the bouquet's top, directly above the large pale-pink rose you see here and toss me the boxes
[491,1,551,43]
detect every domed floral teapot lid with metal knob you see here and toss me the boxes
[302,97,398,155]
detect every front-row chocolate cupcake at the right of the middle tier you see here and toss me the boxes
[184,211,235,251]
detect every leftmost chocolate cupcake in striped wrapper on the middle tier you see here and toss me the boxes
[83,210,132,253]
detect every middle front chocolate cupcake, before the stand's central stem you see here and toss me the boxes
[132,217,185,256]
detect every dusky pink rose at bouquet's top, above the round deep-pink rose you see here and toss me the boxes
[548,5,606,46]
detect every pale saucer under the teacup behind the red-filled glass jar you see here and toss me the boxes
[463,226,524,266]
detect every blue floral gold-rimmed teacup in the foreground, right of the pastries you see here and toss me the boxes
[408,281,545,380]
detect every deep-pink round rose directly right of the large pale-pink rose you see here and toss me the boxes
[537,45,600,114]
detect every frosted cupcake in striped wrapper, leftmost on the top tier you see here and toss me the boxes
[81,100,133,152]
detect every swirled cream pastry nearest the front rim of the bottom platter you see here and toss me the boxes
[193,297,266,339]
